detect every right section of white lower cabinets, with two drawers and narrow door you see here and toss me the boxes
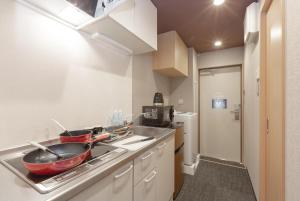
[134,136,175,201]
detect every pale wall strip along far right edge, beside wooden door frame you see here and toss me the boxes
[285,0,300,201]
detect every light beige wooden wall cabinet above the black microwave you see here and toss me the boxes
[153,31,188,77]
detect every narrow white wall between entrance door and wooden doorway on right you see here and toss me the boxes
[244,37,260,198]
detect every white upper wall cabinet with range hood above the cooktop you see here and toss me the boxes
[22,0,157,54]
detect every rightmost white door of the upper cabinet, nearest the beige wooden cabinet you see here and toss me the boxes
[134,0,157,49]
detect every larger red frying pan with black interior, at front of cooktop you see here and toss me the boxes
[22,143,91,175]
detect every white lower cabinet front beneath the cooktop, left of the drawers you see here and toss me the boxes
[69,162,133,201]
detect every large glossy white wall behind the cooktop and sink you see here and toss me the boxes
[0,0,132,149]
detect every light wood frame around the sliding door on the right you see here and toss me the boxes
[259,0,285,201]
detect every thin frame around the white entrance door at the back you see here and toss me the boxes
[198,64,244,164]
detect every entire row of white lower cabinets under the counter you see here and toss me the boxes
[69,136,175,201]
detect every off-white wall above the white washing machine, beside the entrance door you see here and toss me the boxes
[171,48,198,112]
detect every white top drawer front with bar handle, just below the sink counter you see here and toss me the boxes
[134,149,155,185]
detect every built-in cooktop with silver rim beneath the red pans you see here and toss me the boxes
[1,143,127,193]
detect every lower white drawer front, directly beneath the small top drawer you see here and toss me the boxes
[134,170,157,201]
